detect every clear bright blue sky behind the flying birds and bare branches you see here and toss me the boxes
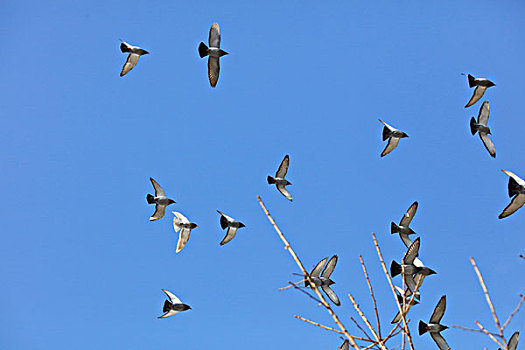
[0,0,525,349]
